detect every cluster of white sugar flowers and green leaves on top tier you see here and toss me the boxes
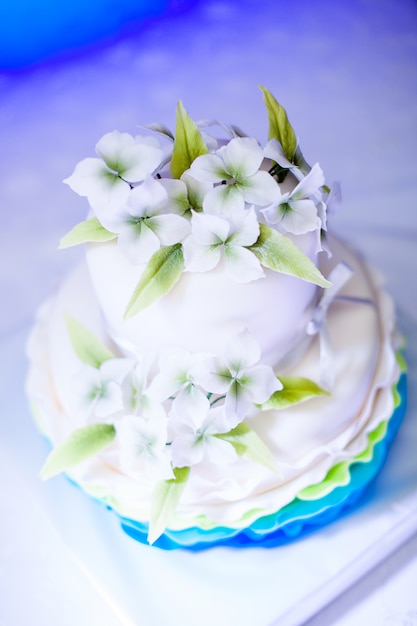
[62,90,330,302]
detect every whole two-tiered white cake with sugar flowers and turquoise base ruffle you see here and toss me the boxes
[28,89,404,548]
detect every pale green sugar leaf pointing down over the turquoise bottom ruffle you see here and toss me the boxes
[148,467,190,544]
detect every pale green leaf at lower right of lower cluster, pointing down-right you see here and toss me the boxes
[215,422,281,474]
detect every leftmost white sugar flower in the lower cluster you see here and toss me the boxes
[72,359,133,423]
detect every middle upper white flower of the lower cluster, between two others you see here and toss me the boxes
[150,348,207,413]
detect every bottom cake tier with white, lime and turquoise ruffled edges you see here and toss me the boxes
[28,236,406,550]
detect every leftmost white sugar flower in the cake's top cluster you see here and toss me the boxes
[64,130,164,214]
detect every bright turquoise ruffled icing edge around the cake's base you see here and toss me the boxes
[116,373,407,551]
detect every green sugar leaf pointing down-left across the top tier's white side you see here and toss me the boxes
[125,243,184,319]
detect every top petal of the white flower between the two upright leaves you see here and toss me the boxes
[221,137,264,180]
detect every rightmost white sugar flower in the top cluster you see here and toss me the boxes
[262,163,324,235]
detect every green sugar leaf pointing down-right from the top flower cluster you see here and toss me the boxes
[248,224,331,287]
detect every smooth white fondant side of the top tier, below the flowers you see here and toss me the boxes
[86,229,318,365]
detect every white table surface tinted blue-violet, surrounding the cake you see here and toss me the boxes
[0,0,417,626]
